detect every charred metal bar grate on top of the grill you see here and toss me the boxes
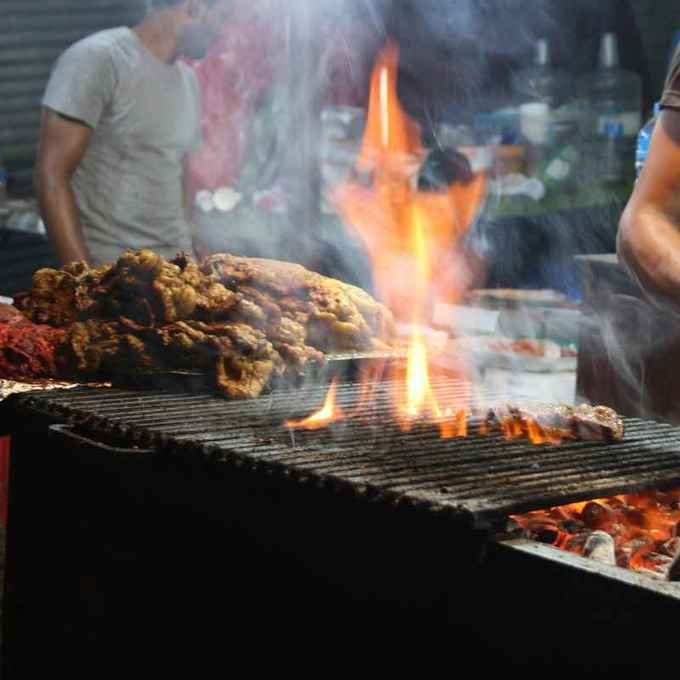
[5,383,680,524]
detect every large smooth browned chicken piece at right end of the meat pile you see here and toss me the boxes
[202,254,394,352]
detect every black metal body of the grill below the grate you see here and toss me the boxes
[3,382,680,677]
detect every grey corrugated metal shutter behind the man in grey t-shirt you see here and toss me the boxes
[0,0,145,190]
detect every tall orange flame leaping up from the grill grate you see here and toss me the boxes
[289,41,486,437]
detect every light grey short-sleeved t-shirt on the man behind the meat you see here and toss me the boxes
[43,28,201,264]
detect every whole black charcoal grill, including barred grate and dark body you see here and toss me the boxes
[1,381,680,669]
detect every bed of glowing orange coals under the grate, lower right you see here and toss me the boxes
[512,489,680,578]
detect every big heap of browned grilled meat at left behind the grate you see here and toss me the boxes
[5,250,393,399]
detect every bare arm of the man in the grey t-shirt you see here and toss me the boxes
[35,109,92,264]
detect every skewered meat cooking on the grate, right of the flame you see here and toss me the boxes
[486,404,624,442]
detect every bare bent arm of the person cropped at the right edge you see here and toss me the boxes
[617,109,680,307]
